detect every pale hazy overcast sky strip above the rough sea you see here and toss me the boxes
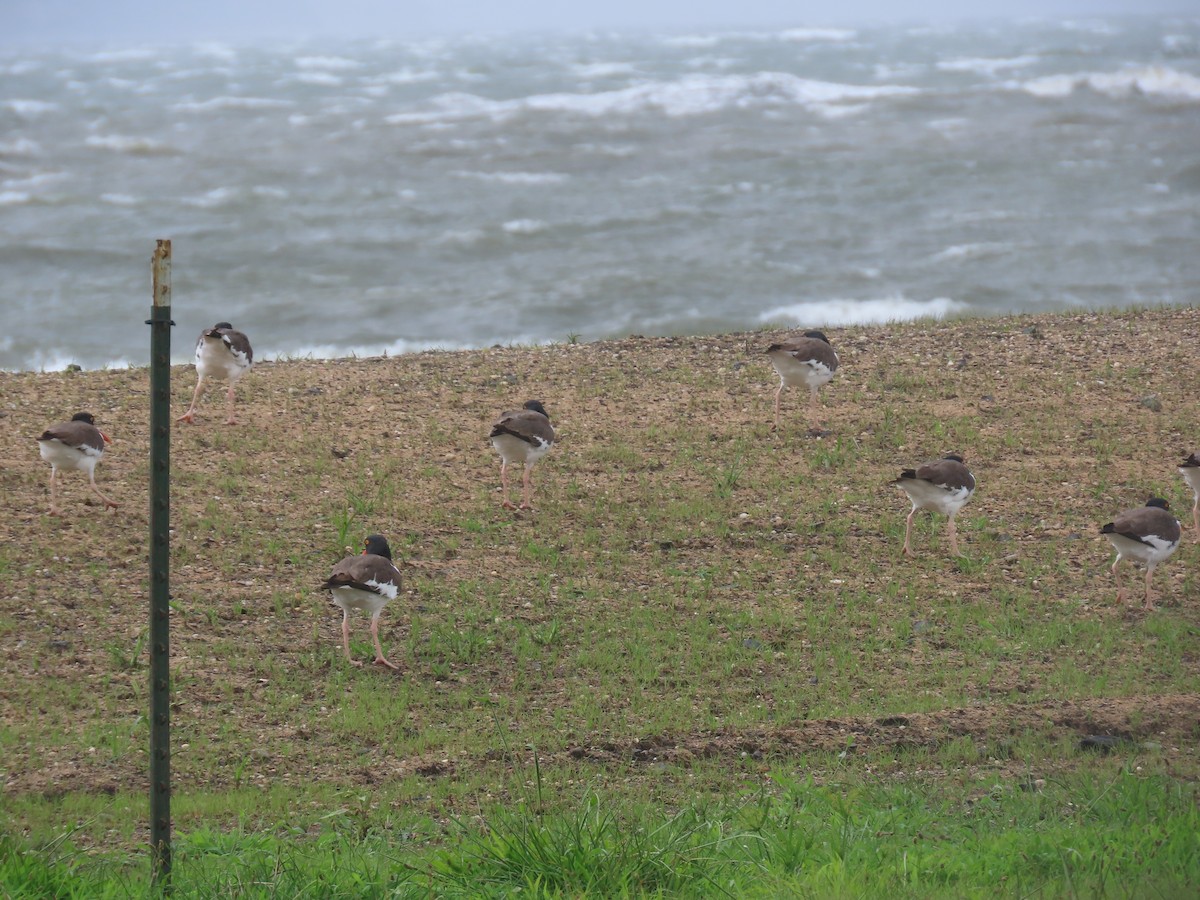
[0,0,1200,44]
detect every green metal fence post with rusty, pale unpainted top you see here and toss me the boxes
[146,240,175,894]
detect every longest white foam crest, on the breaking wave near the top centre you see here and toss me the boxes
[386,72,920,125]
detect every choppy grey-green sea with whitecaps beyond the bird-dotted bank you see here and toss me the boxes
[0,16,1200,370]
